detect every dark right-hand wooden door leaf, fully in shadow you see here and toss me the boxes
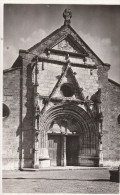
[66,136,79,166]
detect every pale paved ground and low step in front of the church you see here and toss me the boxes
[2,169,119,194]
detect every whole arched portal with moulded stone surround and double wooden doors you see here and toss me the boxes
[39,104,99,166]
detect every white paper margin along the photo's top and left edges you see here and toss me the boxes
[0,0,120,194]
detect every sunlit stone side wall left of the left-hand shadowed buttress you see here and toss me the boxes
[2,69,21,169]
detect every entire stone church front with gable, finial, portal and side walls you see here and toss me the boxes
[2,9,120,169]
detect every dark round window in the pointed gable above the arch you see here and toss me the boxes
[60,83,74,97]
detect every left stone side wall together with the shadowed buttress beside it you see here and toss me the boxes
[3,56,34,169]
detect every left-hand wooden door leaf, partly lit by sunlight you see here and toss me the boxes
[48,135,61,166]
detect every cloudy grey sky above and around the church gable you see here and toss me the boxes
[3,4,120,83]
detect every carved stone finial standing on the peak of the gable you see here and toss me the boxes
[63,8,72,25]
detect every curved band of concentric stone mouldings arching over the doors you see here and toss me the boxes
[40,104,96,132]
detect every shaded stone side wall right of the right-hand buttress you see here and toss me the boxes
[104,80,120,166]
